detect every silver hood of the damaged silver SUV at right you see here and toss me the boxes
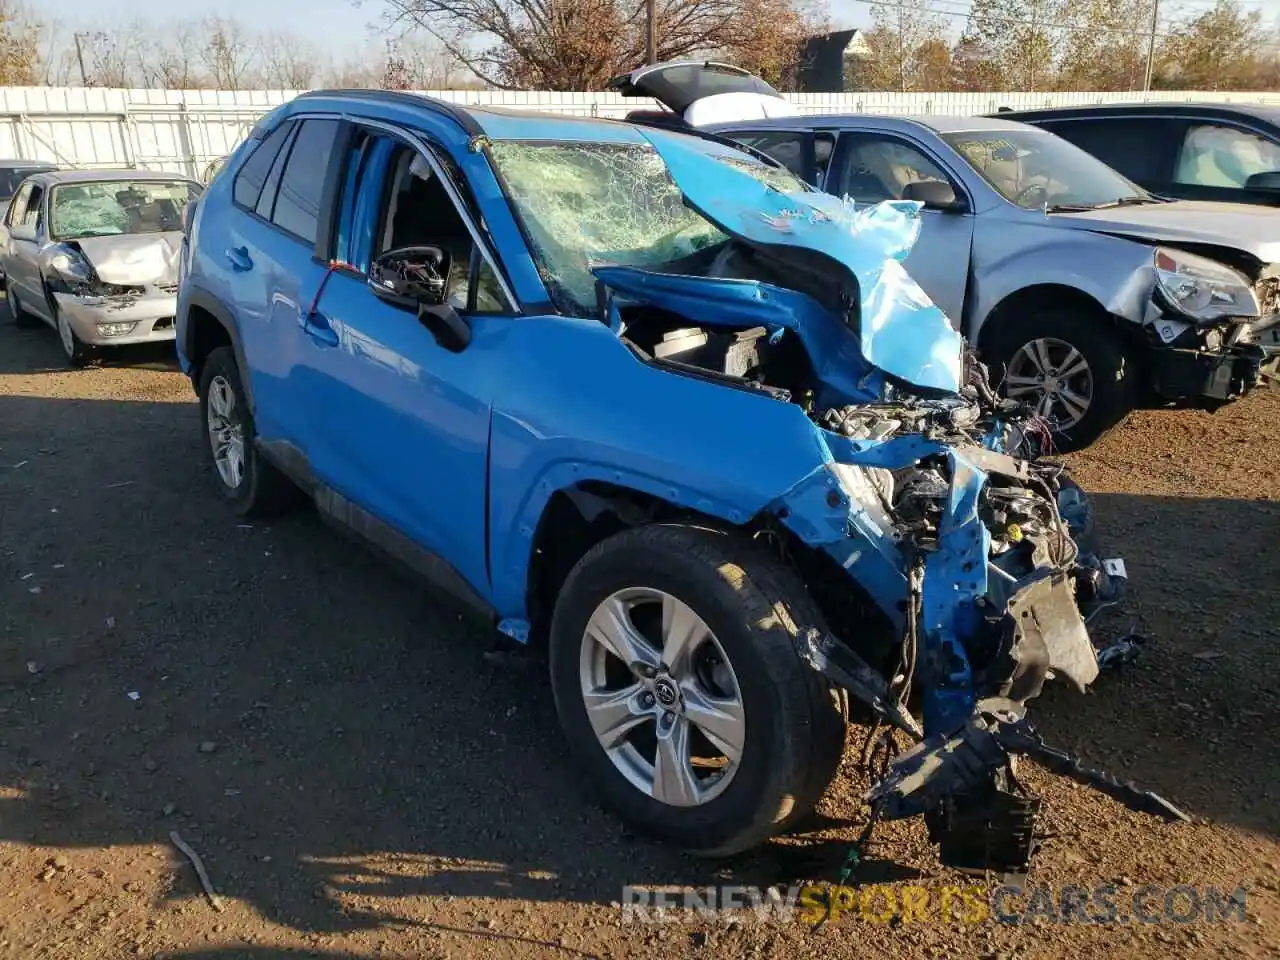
[1052,200,1280,264]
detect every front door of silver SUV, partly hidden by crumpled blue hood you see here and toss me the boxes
[826,132,973,329]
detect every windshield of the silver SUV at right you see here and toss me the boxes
[942,131,1158,212]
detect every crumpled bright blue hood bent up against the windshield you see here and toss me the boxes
[644,129,964,392]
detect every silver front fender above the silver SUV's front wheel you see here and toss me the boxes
[968,220,1156,343]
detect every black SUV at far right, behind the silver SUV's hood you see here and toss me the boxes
[996,102,1280,206]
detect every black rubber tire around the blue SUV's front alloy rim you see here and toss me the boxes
[550,525,845,856]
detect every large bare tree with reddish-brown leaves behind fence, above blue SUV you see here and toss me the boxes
[384,0,810,90]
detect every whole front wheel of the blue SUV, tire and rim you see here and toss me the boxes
[550,525,845,856]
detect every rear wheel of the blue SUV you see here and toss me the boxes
[200,347,298,517]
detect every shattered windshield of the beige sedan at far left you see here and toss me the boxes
[49,180,198,239]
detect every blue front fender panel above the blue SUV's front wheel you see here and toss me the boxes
[489,317,831,618]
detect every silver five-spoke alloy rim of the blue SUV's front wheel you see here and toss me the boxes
[579,588,746,806]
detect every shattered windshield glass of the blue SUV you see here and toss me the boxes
[489,141,804,315]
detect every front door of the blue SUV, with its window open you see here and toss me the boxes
[303,129,520,594]
